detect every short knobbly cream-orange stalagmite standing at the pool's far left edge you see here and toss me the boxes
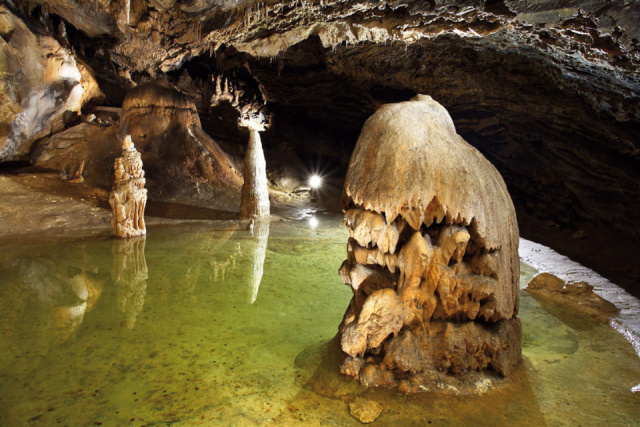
[109,135,147,237]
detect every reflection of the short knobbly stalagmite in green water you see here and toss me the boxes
[111,236,149,329]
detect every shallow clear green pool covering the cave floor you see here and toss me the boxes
[0,216,640,426]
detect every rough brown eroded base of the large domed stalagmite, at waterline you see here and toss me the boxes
[340,318,522,391]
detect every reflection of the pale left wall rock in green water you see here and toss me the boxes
[0,245,104,378]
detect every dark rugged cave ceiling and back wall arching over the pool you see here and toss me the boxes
[7,0,640,290]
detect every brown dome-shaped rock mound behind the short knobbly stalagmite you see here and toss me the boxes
[118,81,242,210]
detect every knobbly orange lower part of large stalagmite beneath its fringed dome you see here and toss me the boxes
[340,208,520,385]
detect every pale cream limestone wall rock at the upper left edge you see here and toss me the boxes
[0,5,103,161]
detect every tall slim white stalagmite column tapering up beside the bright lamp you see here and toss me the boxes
[240,121,270,218]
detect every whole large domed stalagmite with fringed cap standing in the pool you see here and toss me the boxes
[340,95,521,389]
